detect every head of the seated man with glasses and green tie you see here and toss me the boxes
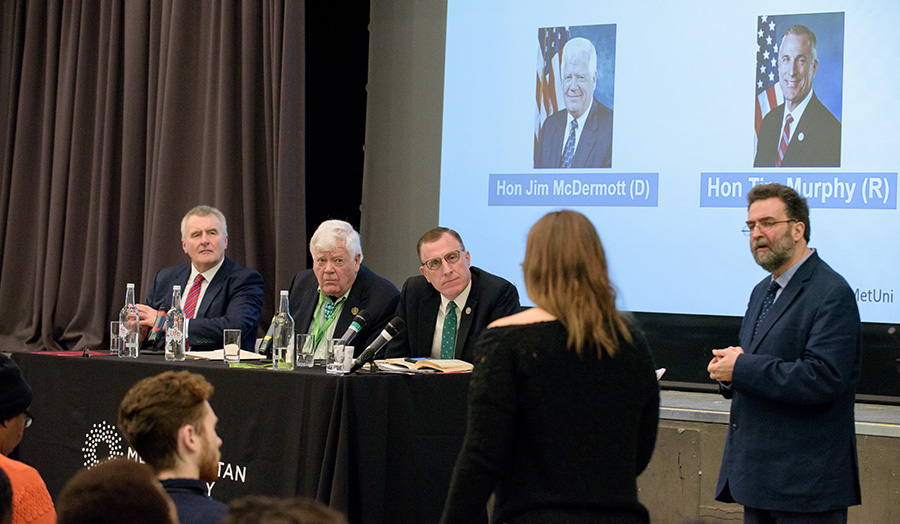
[416,227,472,300]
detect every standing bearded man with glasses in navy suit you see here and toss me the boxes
[707,184,862,524]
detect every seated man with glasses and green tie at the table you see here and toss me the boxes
[387,227,519,363]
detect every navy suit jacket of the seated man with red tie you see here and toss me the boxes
[144,257,264,351]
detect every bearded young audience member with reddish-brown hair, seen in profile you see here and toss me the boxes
[119,371,228,524]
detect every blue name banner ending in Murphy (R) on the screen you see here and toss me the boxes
[700,173,897,209]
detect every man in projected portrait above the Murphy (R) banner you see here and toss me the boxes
[753,24,841,167]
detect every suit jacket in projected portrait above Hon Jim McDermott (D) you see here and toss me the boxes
[534,98,613,168]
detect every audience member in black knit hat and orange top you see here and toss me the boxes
[0,354,56,524]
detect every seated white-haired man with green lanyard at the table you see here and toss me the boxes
[289,220,400,359]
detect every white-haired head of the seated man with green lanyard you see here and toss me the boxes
[309,220,363,297]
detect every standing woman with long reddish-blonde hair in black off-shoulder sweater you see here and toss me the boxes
[441,211,659,524]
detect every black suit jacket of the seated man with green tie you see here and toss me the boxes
[387,267,520,362]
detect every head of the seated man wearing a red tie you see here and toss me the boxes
[181,206,228,273]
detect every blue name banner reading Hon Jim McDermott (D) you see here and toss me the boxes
[488,173,659,207]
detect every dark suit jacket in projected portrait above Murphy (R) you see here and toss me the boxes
[753,92,841,167]
